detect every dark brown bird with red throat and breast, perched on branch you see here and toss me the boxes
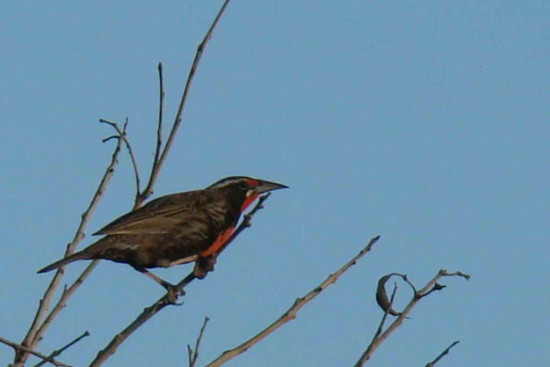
[38,176,287,290]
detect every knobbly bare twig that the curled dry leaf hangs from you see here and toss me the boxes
[354,269,470,367]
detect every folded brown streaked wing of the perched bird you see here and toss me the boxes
[94,193,194,235]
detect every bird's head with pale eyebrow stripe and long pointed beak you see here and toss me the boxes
[208,176,288,212]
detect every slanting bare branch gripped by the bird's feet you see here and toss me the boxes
[89,195,265,367]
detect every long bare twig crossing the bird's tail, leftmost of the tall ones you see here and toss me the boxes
[14,124,127,365]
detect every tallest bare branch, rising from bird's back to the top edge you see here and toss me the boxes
[136,0,234,205]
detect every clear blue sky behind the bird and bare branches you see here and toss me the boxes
[0,0,550,367]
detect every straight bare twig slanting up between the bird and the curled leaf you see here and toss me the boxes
[206,236,380,367]
